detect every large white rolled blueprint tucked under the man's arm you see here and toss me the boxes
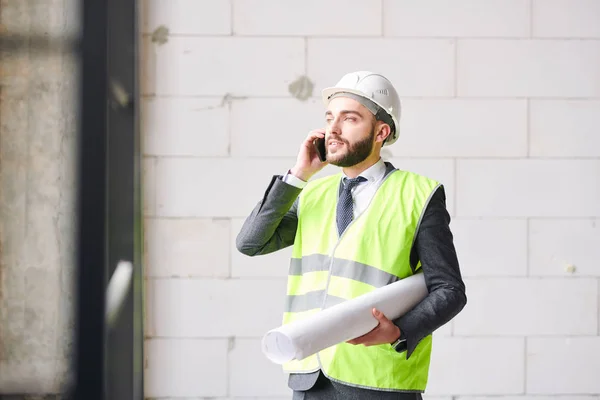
[262,273,428,364]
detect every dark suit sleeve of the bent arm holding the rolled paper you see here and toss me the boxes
[393,186,467,358]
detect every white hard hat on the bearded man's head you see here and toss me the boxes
[322,71,400,146]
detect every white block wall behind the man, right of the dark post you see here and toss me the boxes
[142,0,600,400]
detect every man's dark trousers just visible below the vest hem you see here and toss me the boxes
[292,374,423,400]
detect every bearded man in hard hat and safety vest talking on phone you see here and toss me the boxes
[236,71,466,400]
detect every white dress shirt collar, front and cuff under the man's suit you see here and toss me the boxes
[283,158,386,218]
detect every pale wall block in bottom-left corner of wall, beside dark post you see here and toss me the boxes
[144,339,229,397]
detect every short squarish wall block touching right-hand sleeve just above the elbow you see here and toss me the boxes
[450,218,527,277]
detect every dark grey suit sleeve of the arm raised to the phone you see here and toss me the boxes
[236,175,302,256]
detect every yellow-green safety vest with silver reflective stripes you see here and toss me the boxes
[283,170,439,392]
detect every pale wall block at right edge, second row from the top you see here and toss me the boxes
[457,39,600,97]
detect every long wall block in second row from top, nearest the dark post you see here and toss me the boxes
[145,37,305,96]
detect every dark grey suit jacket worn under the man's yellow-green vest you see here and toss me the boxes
[236,162,467,390]
